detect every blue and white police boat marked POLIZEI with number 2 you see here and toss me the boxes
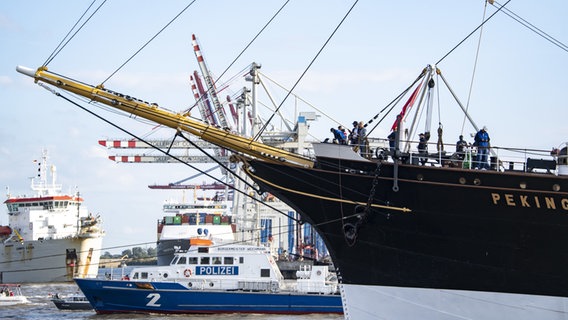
[75,237,343,314]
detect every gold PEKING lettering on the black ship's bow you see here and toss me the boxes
[491,193,568,211]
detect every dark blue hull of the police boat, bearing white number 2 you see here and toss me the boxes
[75,279,343,314]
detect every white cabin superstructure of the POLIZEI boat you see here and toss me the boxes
[127,239,337,294]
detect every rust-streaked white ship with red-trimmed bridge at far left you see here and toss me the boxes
[0,150,104,283]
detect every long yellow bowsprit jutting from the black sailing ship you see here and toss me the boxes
[16,66,314,168]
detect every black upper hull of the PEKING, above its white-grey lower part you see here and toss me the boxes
[247,158,568,318]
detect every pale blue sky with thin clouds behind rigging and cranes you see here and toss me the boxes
[0,0,568,252]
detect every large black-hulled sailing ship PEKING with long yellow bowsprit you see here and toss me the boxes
[17,60,568,319]
